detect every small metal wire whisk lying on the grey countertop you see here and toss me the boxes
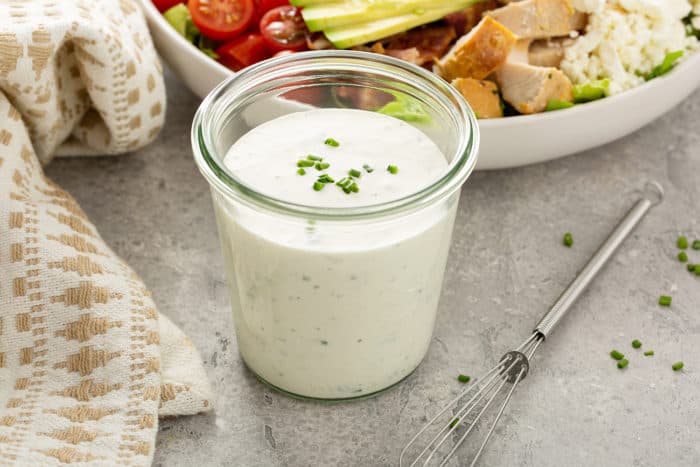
[399,182,663,467]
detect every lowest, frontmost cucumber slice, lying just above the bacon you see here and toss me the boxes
[324,4,476,49]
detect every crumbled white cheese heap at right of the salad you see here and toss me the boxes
[561,0,700,94]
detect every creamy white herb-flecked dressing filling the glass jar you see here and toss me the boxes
[219,109,459,399]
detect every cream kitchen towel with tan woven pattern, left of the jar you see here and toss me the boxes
[0,0,210,466]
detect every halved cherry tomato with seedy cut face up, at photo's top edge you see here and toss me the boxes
[188,0,255,41]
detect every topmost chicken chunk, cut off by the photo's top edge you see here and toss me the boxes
[486,0,574,39]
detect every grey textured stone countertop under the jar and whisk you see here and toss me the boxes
[47,70,700,467]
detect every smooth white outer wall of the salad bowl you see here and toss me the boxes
[140,0,700,170]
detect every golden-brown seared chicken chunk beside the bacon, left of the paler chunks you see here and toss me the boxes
[433,16,516,81]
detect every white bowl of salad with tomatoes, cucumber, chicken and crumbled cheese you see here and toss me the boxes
[141,0,700,169]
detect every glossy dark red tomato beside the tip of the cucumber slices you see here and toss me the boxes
[260,6,307,51]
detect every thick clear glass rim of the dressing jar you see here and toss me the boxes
[191,50,479,219]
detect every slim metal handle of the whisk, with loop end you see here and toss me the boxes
[535,182,664,337]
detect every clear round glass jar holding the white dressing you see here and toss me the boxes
[192,51,479,400]
